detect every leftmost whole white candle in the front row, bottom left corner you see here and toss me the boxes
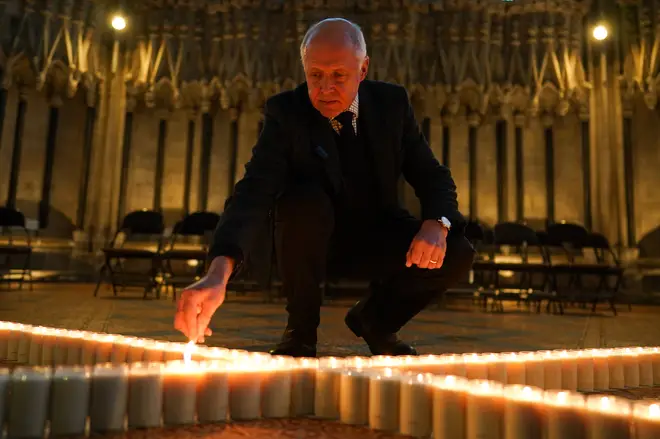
[7,367,52,438]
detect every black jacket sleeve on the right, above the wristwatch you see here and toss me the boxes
[400,84,465,232]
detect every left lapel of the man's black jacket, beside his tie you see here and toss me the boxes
[296,84,343,193]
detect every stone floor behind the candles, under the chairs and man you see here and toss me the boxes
[0,284,660,355]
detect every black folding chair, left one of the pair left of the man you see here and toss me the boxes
[94,209,165,299]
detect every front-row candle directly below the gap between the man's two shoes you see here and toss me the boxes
[314,357,344,419]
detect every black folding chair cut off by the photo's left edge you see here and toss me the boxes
[0,207,32,290]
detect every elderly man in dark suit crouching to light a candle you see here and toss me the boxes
[175,18,474,356]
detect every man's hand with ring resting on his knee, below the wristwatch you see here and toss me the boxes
[406,220,448,270]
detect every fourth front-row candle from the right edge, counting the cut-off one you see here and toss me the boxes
[504,385,543,439]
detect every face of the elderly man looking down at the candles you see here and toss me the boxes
[303,41,369,118]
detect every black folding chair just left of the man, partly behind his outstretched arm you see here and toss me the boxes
[160,212,220,300]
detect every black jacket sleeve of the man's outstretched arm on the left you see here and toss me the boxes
[208,101,291,271]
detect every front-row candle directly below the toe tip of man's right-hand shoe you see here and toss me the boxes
[399,374,433,437]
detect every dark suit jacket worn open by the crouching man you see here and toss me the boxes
[209,80,464,272]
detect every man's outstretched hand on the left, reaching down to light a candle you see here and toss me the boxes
[174,256,234,343]
